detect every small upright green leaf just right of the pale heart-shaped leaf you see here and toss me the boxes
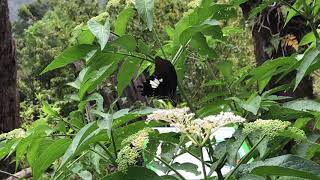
[114,8,134,36]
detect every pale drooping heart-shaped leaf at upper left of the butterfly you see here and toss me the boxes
[88,19,110,50]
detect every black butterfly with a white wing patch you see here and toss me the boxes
[138,56,177,100]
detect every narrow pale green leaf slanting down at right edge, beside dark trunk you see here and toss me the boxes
[294,48,320,89]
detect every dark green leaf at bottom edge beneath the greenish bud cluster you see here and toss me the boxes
[102,167,161,180]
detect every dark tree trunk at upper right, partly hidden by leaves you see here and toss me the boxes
[240,0,313,99]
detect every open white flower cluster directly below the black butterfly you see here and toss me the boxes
[147,108,245,145]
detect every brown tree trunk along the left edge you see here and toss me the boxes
[0,0,19,179]
